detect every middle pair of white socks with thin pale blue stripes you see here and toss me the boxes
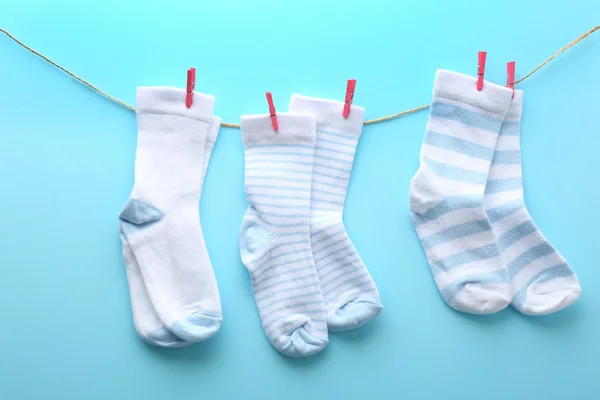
[240,95,382,357]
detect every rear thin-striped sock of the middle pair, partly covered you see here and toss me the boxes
[289,95,382,331]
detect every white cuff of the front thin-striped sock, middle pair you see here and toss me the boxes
[240,113,316,147]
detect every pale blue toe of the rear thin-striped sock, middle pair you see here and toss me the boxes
[327,295,383,332]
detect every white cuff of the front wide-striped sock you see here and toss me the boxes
[433,69,513,118]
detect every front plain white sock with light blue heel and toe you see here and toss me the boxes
[119,87,222,341]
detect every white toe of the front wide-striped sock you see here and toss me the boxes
[449,283,511,315]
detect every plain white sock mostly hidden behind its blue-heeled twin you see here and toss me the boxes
[121,117,221,347]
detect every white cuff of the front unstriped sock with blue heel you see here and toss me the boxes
[136,86,215,122]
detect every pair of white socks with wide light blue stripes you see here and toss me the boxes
[410,70,581,315]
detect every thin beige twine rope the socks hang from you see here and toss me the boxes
[0,25,600,128]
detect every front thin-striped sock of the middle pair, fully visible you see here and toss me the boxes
[240,113,328,357]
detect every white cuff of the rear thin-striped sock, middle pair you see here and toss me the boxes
[288,94,365,138]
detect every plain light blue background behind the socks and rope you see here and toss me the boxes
[0,0,600,400]
